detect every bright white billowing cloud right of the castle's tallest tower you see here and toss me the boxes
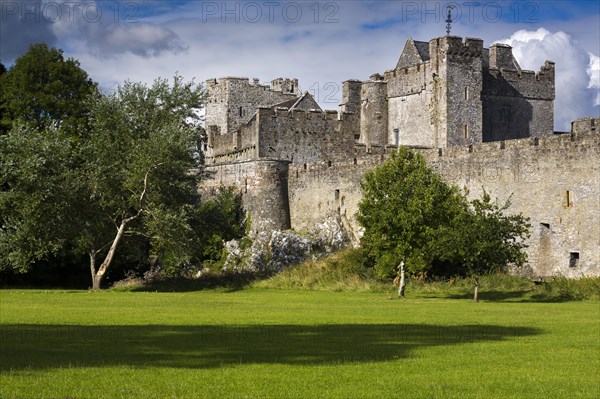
[497,28,599,130]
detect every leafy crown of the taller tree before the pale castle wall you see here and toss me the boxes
[357,147,464,284]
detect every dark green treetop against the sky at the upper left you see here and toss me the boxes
[0,43,98,135]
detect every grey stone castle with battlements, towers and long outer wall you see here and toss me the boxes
[201,36,600,277]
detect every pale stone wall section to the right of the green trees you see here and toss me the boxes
[426,133,600,277]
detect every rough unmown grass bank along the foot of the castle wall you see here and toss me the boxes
[252,249,600,302]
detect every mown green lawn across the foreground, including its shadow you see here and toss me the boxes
[0,288,600,399]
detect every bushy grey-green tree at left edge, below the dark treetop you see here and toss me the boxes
[0,125,80,272]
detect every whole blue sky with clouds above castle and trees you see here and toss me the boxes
[0,0,600,131]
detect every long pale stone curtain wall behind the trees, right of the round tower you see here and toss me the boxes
[282,133,600,277]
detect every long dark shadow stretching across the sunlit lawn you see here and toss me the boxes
[0,324,541,371]
